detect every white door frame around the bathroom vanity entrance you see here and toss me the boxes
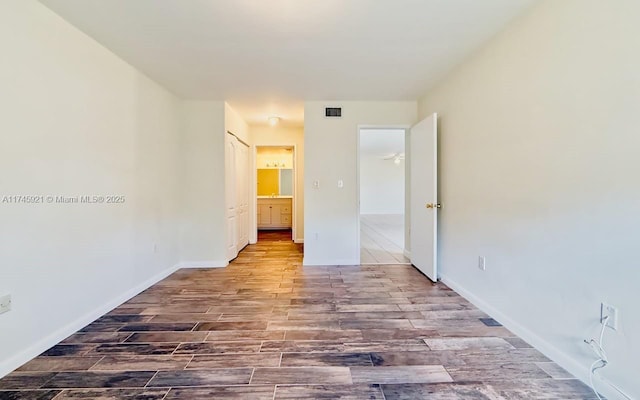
[249,143,299,244]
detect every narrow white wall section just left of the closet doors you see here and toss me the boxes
[180,101,227,267]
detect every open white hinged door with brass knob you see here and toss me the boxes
[409,114,440,282]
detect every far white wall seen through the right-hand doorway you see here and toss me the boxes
[360,155,404,214]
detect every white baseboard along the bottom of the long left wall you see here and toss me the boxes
[0,265,180,378]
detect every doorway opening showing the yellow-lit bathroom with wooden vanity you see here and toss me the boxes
[255,146,296,241]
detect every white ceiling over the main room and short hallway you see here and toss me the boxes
[41,0,535,124]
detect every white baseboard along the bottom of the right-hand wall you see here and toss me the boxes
[440,274,627,400]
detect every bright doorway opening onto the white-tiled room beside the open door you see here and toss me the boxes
[358,128,411,264]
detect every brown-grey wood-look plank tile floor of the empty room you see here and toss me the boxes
[0,232,595,400]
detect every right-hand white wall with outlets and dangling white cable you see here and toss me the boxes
[419,0,640,398]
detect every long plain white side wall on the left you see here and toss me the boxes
[0,0,182,376]
